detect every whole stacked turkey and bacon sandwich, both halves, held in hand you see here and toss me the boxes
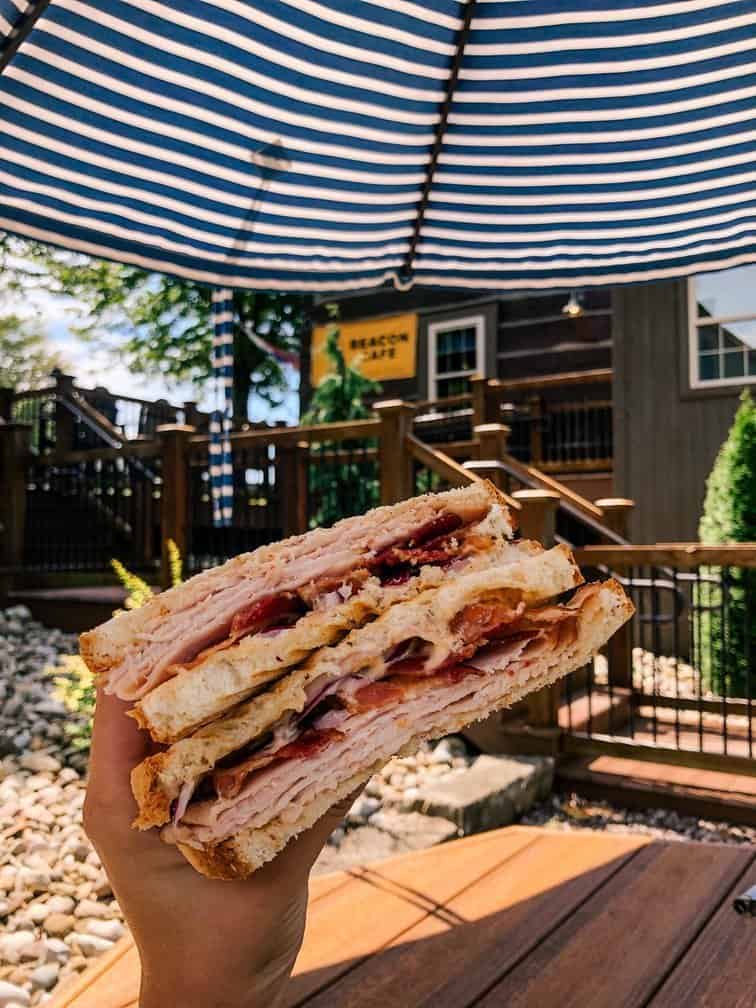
[83,483,632,879]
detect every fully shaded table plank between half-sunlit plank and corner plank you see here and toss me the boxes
[480,843,751,1008]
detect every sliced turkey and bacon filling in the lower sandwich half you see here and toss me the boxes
[163,586,599,846]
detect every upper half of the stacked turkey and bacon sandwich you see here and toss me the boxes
[82,481,521,743]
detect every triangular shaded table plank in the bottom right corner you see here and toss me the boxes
[649,854,756,1008]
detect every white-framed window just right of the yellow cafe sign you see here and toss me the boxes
[428,316,486,399]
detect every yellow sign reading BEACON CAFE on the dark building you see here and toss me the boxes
[310,314,417,387]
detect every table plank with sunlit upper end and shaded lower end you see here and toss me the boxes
[298,833,646,1008]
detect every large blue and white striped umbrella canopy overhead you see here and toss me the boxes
[0,0,756,290]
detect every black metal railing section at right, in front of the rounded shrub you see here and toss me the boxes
[561,560,756,759]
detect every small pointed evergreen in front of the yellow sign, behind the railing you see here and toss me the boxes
[302,304,381,527]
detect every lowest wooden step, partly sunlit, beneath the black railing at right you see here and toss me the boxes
[555,756,756,826]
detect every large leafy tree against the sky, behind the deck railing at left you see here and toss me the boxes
[0,235,305,419]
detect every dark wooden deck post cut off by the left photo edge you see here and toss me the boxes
[0,423,31,600]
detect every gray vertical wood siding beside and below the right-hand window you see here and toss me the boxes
[614,280,741,543]
